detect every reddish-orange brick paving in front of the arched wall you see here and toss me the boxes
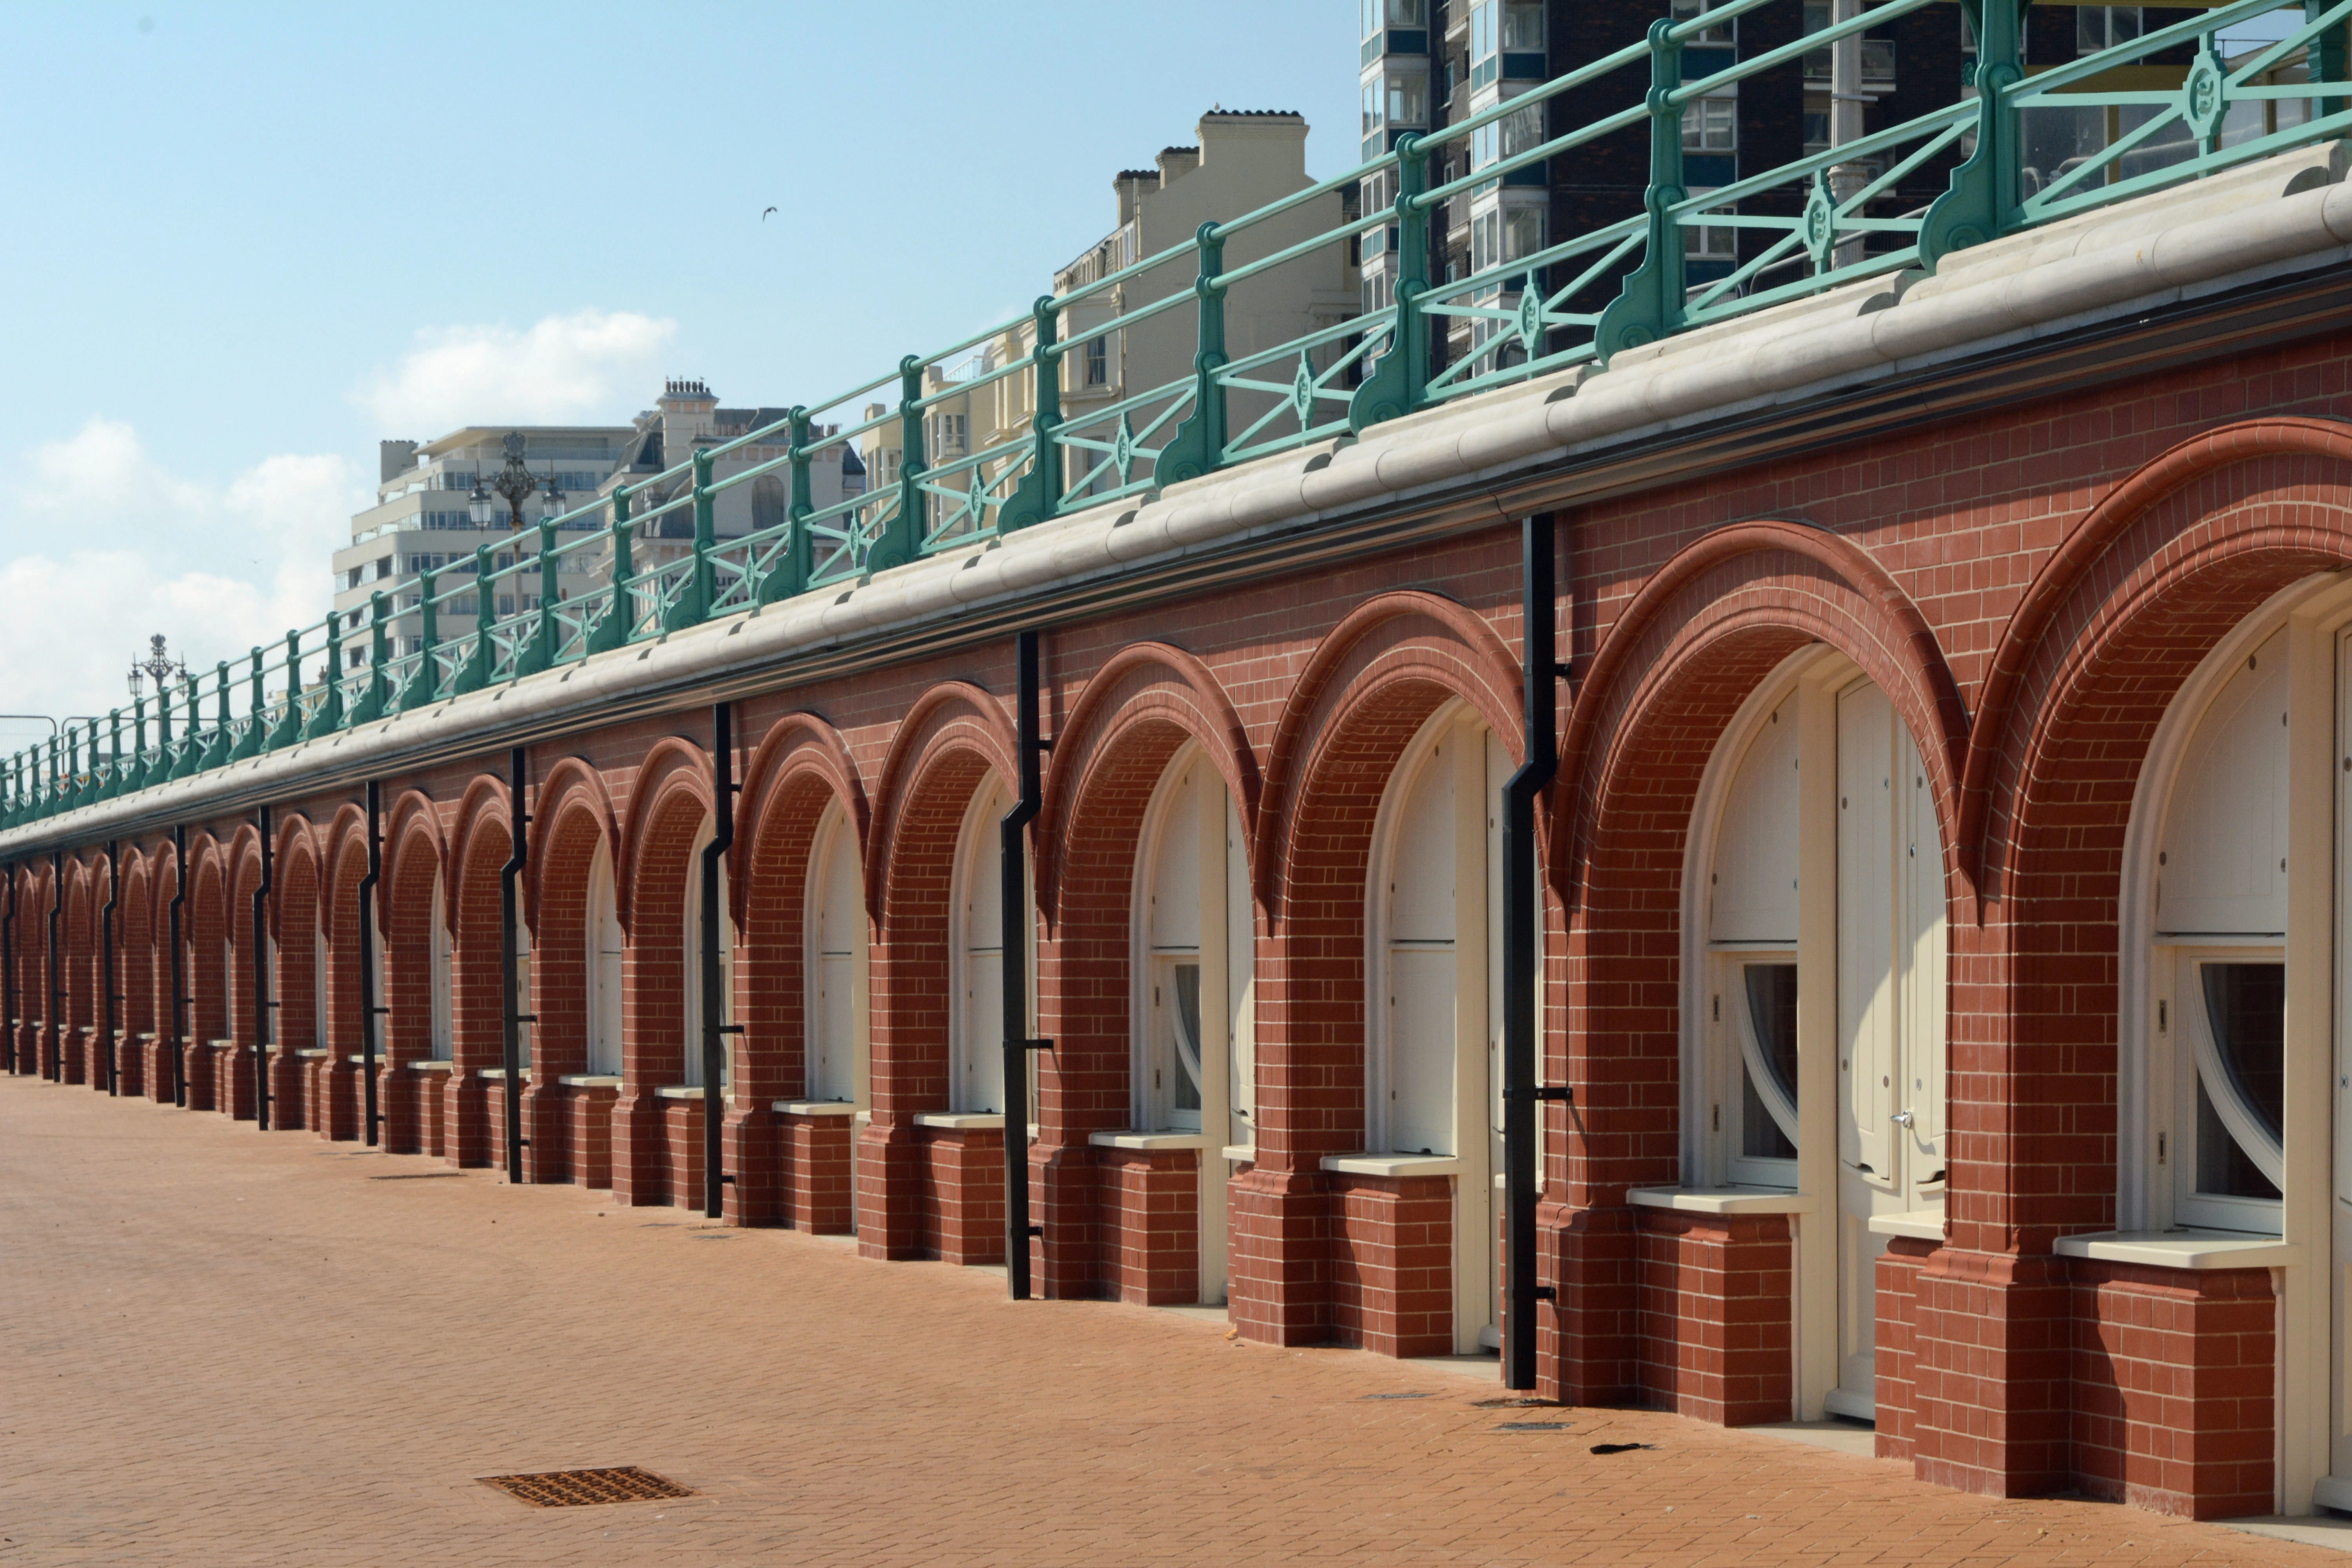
[0,1079,2340,1568]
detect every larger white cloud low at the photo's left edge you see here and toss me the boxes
[0,418,367,752]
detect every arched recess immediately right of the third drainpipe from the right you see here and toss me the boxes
[731,715,868,1103]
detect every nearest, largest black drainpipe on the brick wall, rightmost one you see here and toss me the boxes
[1503,512,1571,1389]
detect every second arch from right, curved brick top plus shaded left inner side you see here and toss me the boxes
[1550,522,1962,1206]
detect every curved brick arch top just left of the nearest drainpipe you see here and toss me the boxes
[1249,590,1526,924]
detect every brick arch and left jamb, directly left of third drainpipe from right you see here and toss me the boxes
[614,740,717,1093]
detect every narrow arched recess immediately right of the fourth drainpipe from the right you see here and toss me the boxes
[529,757,626,1084]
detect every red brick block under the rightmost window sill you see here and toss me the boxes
[2067,1258,2277,1519]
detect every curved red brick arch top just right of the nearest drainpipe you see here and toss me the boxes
[1550,519,1971,910]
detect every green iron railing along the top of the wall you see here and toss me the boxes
[0,0,2352,828]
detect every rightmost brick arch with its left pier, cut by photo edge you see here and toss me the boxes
[1950,446,2352,1253]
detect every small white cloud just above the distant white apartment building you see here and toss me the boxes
[350,310,677,439]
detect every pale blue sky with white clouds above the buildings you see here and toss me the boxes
[0,0,1355,748]
